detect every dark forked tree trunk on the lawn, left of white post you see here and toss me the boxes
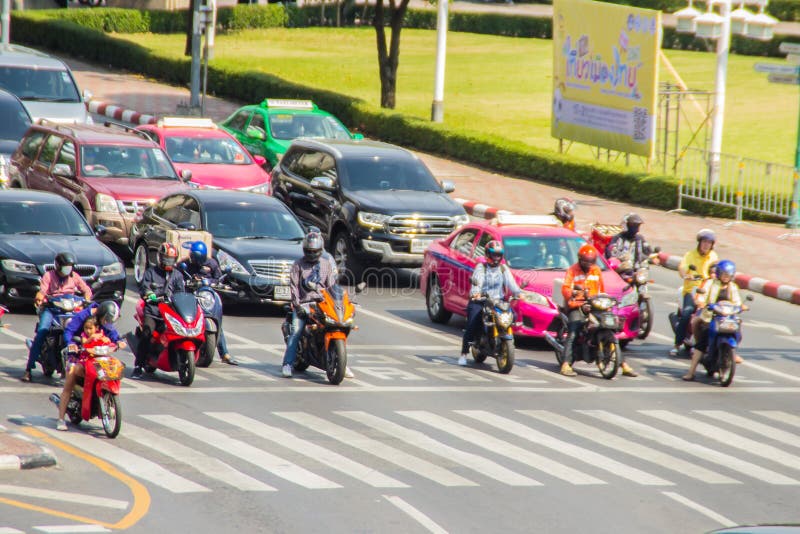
[372,0,409,109]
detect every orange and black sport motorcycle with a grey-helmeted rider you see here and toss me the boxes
[281,285,356,386]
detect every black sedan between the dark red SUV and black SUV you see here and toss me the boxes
[129,190,304,303]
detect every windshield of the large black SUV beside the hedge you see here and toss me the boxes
[341,156,442,193]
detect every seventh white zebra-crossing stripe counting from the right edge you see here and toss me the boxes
[397,411,605,485]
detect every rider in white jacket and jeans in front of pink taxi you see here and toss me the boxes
[458,240,520,365]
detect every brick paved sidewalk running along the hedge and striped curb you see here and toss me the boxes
[67,59,800,287]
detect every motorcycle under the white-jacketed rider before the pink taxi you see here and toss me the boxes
[470,296,514,374]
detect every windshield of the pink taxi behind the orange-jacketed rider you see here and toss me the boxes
[503,236,607,271]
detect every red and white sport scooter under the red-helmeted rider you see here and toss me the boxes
[134,293,206,386]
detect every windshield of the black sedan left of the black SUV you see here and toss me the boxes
[206,202,303,241]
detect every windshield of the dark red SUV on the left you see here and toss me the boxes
[80,145,178,180]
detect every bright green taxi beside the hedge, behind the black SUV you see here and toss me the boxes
[220,98,364,167]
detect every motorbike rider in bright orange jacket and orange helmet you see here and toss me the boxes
[560,243,638,377]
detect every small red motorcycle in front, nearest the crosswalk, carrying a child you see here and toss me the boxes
[50,343,125,439]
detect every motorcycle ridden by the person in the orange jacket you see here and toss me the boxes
[544,293,622,380]
